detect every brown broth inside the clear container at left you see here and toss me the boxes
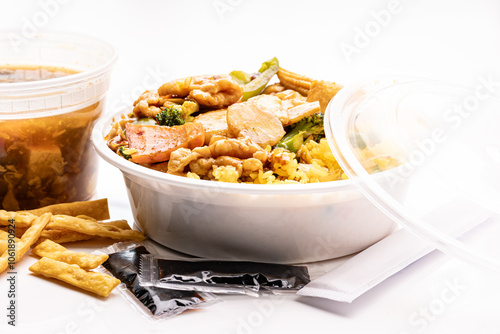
[0,67,103,210]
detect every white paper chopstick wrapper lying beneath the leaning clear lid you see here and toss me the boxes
[297,201,490,303]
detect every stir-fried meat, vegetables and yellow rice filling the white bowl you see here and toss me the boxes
[105,58,397,184]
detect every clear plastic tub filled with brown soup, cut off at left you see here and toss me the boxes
[0,32,117,210]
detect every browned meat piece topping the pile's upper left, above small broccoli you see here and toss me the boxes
[158,74,243,108]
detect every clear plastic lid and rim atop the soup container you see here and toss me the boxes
[0,31,117,120]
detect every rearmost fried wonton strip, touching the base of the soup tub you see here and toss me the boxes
[26,198,110,220]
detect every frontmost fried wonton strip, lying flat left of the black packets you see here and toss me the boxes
[29,257,120,297]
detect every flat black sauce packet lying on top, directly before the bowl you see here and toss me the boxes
[140,255,310,296]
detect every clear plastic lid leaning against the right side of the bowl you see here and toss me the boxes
[325,75,500,271]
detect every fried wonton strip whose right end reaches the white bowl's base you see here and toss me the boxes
[47,215,144,241]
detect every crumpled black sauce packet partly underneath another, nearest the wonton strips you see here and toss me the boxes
[95,243,217,320]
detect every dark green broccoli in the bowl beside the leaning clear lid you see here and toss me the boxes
[276,112,325,152]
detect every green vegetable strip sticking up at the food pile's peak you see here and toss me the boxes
[230,57,280,101]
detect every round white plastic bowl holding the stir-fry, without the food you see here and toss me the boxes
[92,111,404,263]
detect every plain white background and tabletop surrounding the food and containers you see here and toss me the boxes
[0,0,500,334]
